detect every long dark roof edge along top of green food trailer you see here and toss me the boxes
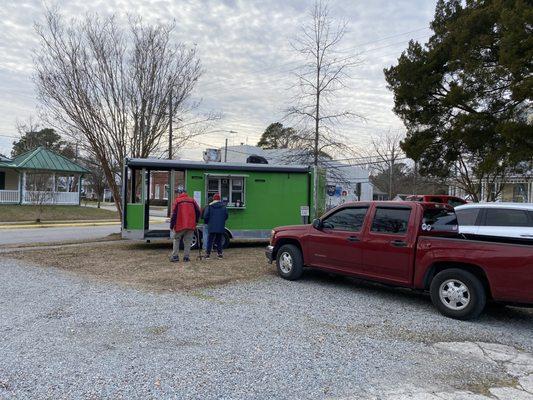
[126,158,310,173]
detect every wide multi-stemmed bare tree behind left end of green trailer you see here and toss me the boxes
[35,10,202,216]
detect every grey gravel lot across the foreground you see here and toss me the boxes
[0,258,533,399]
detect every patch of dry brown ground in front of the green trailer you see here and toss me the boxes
[3,241,275,291]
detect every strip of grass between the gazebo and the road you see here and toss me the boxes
[0,205,118,223]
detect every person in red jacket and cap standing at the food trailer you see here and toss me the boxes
[170,186,200,262]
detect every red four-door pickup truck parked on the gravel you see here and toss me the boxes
[266,201,533,319]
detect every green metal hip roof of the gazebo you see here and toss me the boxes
[0,146,89,174]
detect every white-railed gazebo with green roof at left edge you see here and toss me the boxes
[0,147,89,205]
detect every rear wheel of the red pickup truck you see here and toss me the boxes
[430,268,487,320]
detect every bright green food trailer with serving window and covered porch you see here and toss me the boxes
[122,158,325,246]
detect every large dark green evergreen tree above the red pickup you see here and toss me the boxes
[384,0,533,200]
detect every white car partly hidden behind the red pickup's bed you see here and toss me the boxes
[455,203,533,239]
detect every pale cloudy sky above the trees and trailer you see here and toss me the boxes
[0,0,435,159]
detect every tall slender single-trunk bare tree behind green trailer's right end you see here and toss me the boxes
[287,0,360,215]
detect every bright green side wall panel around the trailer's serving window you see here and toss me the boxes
[186,170,310,230]
